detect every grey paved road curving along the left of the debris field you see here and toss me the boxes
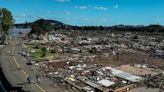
[1,39,66,92]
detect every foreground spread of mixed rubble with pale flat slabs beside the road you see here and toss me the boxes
[37,62,145,92]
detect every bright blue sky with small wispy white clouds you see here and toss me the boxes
[0,0,164,26]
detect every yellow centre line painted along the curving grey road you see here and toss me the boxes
[12,47,46,92]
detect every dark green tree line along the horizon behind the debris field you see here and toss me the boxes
[31,20,164,34]
